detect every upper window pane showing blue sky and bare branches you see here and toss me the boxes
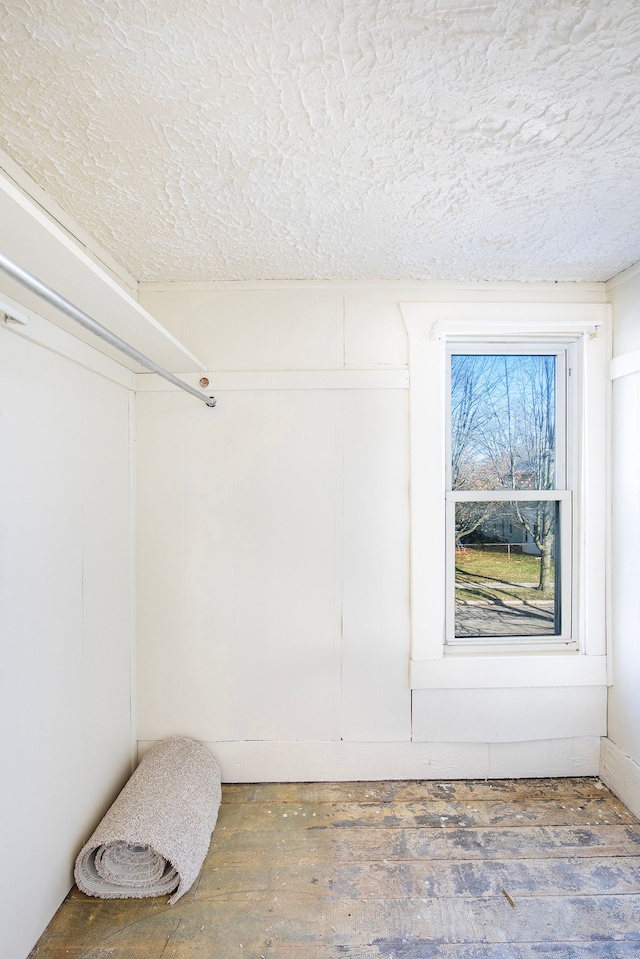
[451,353,556,490]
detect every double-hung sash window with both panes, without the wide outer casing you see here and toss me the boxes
[446,342,576,644]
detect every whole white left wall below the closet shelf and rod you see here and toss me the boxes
[0,321,132,959]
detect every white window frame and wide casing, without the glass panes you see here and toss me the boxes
[400,302,610,688]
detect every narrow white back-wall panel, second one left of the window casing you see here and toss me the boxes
[278,390,340,740]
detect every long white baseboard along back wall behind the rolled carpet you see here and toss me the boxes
[138,736,600,783]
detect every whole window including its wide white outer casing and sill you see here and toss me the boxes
[400,302,609,689]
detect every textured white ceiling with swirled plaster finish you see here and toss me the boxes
[0,0,640,280]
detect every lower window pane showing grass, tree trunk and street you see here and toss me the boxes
[455,501,560,637]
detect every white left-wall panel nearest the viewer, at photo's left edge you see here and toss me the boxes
[0,331,82,959]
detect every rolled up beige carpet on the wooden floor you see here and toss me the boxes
[75,736,221,903]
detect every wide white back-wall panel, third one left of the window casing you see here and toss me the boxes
[185,393,278,739]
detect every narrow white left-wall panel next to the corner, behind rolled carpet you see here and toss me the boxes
[80,372,135,834]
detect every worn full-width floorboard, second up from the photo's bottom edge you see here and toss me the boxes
[31,891,640,959]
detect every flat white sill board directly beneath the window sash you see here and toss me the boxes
[409,647,607,689]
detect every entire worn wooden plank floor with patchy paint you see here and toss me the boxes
[31,779,640,959]
